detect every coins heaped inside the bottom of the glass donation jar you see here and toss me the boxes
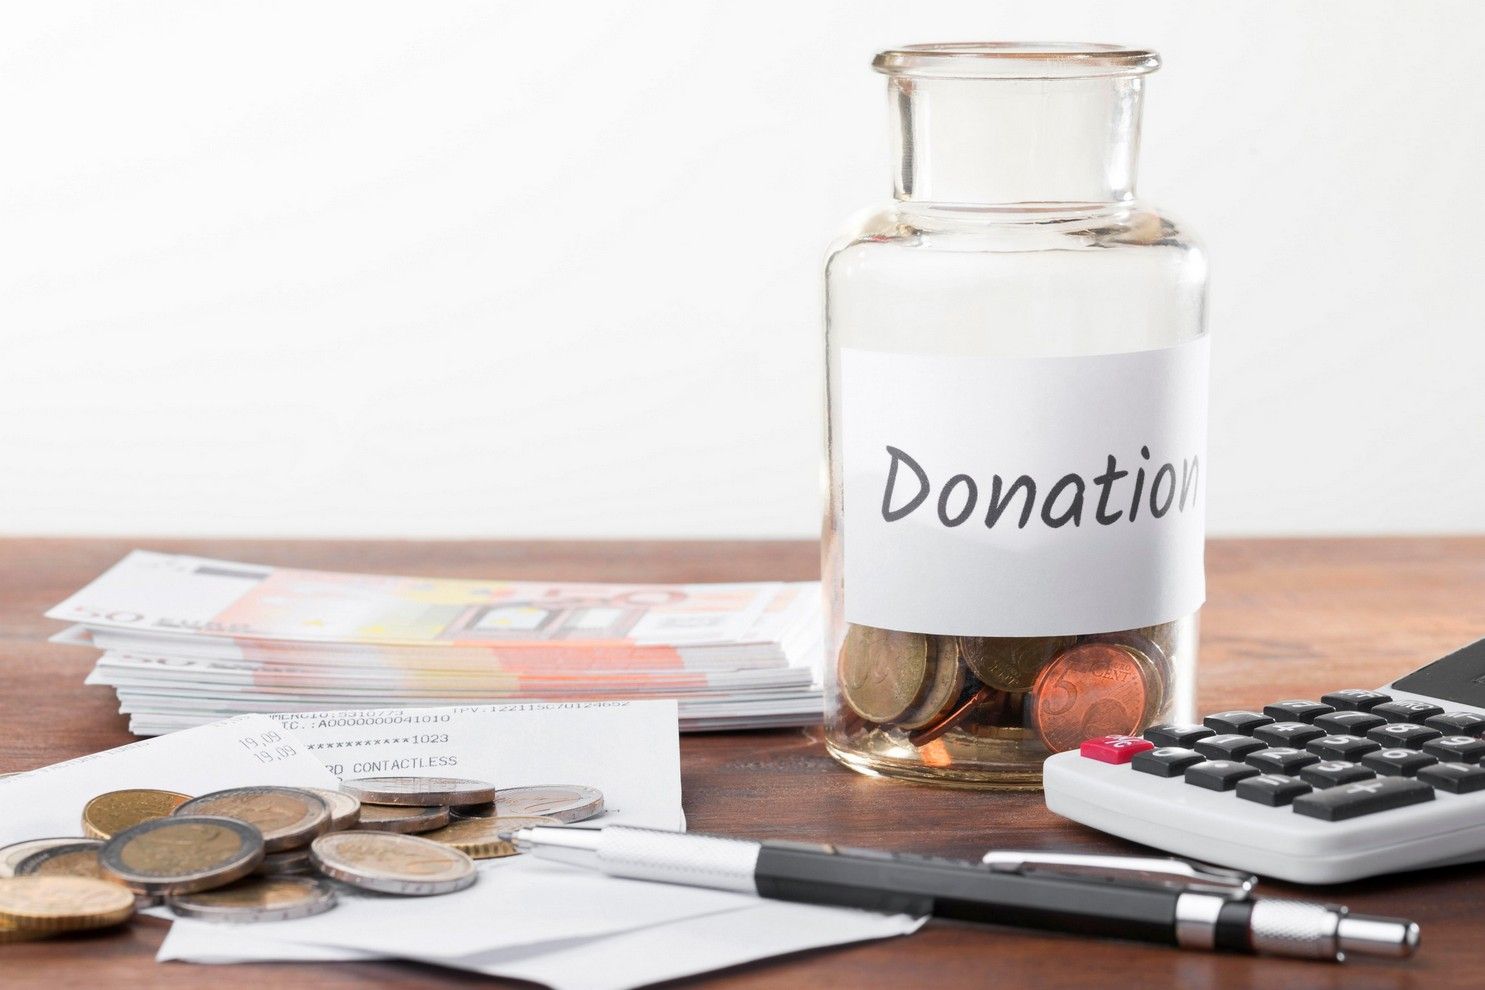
[838,622,1178,753]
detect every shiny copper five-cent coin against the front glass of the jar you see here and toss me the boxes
[1031,643,1158,753]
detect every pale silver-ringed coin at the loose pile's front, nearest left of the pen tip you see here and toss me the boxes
[309,831,478,895]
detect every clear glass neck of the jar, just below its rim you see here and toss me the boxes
[888,76,1143,209]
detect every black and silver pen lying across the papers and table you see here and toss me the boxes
[512,825,1418,960]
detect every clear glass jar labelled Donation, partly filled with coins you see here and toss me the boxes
[823,43,1207,788]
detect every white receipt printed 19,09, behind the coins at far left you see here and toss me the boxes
[0,715,337,845]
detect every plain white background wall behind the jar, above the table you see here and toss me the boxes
[0,0,1485,536]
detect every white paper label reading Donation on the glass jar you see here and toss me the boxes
[841,337,1209,635]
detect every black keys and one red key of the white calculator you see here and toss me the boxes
[1081,689,1485,821]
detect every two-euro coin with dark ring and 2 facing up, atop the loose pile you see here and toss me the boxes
[101,815,263,894]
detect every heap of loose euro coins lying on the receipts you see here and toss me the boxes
[0,776,603,943]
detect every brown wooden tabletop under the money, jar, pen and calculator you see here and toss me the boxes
[0,539,1485,990]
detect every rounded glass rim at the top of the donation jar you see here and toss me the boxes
[872,42,1160,79]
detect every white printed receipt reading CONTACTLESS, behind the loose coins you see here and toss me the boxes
[270,701,686,830]
